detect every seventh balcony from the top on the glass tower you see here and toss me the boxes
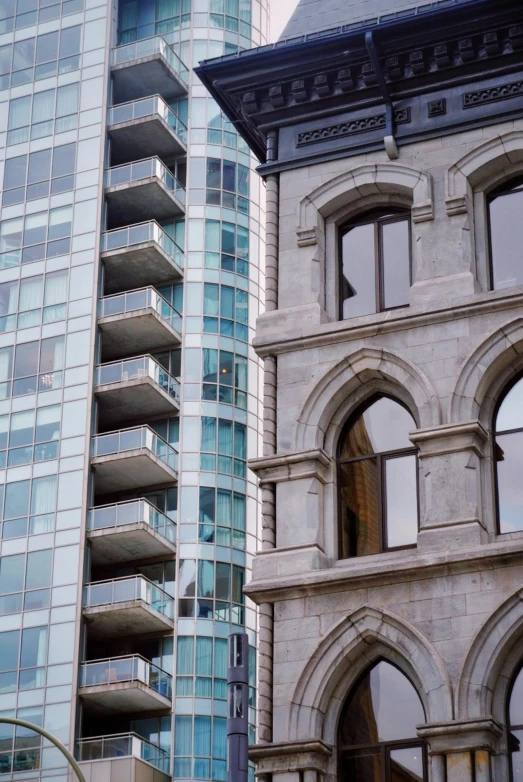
[91,426,178,494]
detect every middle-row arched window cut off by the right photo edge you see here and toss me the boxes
[494,378,523,532]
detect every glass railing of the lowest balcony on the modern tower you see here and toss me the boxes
[76,733,169,774]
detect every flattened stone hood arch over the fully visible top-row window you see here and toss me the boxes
[297,163,434,245]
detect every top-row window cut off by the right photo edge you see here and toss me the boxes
[488,180,523,291]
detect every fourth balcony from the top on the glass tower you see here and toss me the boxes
[101,220,183,293]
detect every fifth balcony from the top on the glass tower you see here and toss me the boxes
[98,287,182,359]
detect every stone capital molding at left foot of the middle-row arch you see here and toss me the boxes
[248,448,331,485]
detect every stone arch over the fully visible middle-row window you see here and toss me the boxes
[295,348,441,454]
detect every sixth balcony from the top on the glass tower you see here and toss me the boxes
[94,356,180,428]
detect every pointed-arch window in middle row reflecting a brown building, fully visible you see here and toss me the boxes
[338,396,419,559]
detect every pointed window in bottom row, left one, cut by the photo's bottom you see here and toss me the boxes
[338,660,428,782]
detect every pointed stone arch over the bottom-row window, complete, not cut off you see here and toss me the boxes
[288,606,453,744]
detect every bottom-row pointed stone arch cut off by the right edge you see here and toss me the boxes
[456,589,523,724]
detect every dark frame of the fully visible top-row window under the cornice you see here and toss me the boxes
[337,207,412,320]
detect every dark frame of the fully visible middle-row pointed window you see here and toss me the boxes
[336,393,420,559]
